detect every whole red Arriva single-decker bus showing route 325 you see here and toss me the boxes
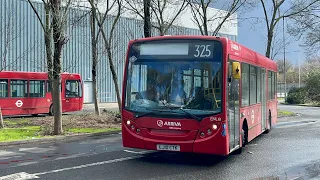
[122,36,277,155]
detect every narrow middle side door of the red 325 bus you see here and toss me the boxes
[260,68,267,131]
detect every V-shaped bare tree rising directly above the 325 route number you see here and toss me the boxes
[188,0,246,36]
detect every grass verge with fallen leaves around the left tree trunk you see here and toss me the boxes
[0,112,121,142]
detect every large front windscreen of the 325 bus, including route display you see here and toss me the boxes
[125,40,222,116]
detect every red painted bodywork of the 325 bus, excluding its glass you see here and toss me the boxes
[122,36,277,155]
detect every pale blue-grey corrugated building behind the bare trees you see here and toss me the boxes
[0,0,237,103]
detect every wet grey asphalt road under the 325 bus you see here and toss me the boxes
[0,105,320,180]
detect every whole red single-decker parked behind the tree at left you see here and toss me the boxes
[0,71,83,116]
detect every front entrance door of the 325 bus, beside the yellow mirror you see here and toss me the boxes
[227,60,240,151]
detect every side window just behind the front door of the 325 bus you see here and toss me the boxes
[241,63,250,106]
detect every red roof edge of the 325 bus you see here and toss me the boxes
[129,35,277,71]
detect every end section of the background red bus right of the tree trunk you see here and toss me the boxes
[62,80,82,112]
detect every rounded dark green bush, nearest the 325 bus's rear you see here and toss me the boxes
[286,88,308,104]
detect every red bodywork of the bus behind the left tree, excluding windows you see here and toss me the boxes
[0,71,83,116]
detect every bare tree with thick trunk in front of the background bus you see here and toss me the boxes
[28,0,71,135]
